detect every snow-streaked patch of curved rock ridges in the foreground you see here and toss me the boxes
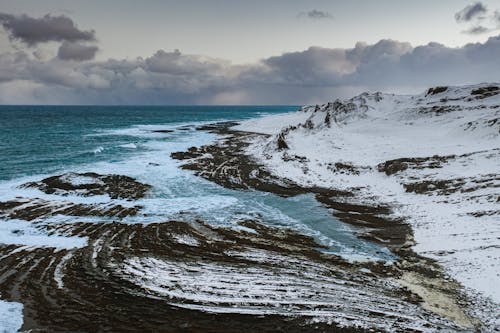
[120,254,460,332]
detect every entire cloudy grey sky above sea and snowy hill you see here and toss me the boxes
[0,0,500,104]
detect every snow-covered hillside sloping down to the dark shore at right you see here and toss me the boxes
[235,84,500,324]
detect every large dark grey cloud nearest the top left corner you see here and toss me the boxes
[0,13,95,46]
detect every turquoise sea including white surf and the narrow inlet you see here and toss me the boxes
[0,106,392,260]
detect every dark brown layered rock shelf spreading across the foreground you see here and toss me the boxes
[0,221,466,333]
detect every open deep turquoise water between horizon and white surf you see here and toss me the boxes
[0,106,297,180]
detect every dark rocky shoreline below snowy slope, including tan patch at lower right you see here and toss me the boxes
[172,122,488,329]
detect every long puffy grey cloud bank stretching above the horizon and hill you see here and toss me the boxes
[0,36,500,104]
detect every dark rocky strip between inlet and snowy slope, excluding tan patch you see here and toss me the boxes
[172,122,426,252]
